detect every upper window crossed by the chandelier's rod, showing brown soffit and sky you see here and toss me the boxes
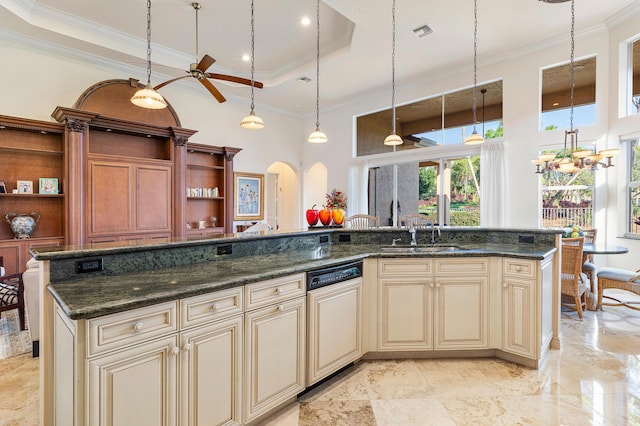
[540,57,596,131]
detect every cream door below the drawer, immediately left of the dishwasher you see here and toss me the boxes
[244,297,306,422]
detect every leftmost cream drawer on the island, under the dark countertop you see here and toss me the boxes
[87,302,178,356]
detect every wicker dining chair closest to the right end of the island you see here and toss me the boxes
[560,237,588,319]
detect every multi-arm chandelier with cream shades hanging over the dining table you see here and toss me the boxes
[531,0,619,174]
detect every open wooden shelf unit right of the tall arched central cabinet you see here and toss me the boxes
[185,143,240,237]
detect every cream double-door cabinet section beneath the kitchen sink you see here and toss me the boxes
[378,258,489,351]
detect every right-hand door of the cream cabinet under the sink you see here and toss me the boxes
[434,276,489,349]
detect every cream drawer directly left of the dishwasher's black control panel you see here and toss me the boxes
[245,274,306,310]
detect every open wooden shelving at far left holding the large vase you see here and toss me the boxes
[0,116,66,274]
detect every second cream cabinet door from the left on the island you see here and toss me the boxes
[180,315,243,426]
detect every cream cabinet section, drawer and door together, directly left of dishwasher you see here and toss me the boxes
[244,274,306,422]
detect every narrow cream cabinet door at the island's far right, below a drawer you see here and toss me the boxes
[502,275,537,358]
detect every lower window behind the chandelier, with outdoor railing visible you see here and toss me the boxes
[542,150,594,229]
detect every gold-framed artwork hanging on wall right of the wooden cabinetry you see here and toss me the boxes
[233,172,264,220]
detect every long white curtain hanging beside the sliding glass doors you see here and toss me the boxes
[480,141,509,228]
